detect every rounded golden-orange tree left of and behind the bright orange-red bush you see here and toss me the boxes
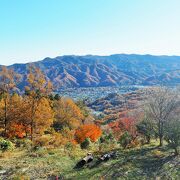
[54,98,84,131]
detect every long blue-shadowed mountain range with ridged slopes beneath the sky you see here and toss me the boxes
[1,54,180,90]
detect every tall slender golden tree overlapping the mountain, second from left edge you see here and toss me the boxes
[25,65,52,141]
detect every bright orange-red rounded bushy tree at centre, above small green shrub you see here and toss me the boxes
[75,124,102,143]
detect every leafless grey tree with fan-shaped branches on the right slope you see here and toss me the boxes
[146,87,179,146]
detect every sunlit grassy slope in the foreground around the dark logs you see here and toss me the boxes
[0,143,180,180]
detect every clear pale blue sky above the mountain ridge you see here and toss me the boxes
[0,0,180,64]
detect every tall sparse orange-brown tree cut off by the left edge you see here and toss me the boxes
[0,66,20,134]
